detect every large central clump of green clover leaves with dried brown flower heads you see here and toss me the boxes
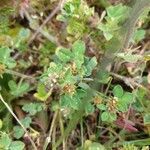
[40,40,97,113]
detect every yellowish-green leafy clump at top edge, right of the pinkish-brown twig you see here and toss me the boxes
[57,0,94,41]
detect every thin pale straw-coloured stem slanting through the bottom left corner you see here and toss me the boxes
[0,94,37,150]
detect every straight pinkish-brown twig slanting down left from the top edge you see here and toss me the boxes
[28,0,66,44]
